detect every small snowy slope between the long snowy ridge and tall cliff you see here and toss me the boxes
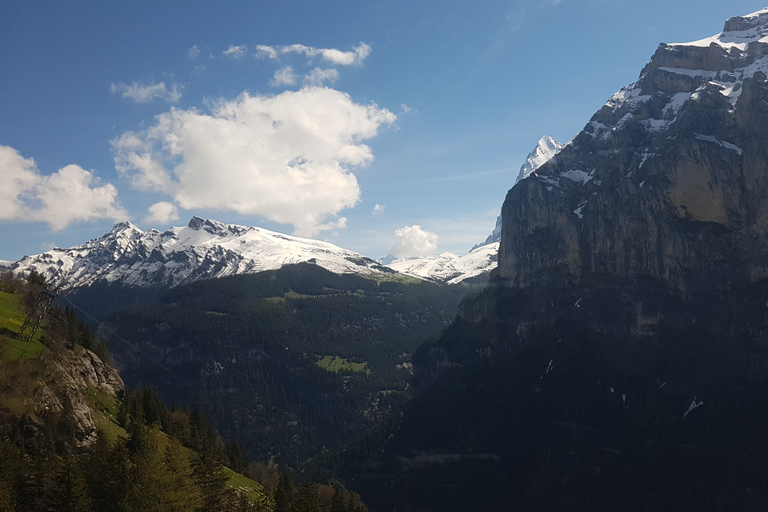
[387,243,499,284]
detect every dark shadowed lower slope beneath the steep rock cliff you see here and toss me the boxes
[355,280,768,511]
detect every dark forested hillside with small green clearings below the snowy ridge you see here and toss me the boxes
[99,264,471,464]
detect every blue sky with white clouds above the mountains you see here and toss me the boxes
[0,0,766,261]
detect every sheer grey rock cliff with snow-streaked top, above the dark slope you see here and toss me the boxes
[499,10,768,290]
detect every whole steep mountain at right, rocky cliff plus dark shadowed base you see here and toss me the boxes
[354,9,768,511]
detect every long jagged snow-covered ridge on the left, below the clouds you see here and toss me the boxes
[13,217,391,291]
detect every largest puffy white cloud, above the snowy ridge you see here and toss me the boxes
[112,87,395,236]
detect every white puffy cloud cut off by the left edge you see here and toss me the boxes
[0,145,128,230]
